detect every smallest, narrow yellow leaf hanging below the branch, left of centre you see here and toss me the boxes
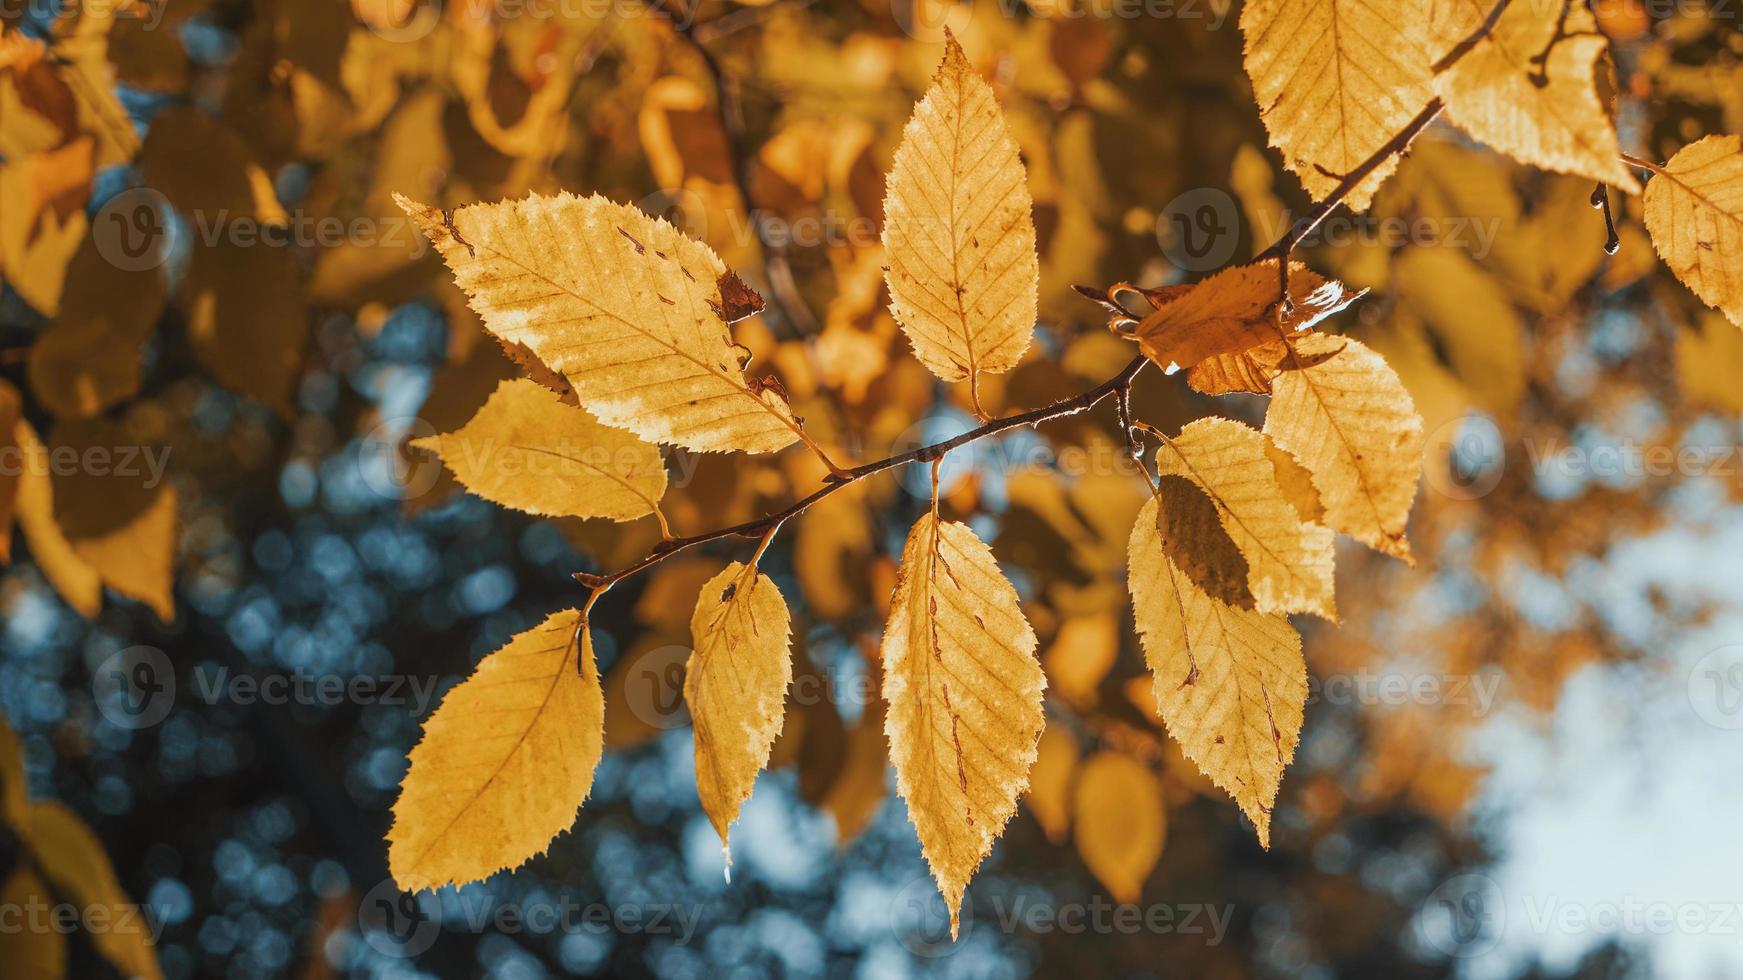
[683,561,793,850]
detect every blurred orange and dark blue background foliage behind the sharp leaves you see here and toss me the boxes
[0,0,1743,978]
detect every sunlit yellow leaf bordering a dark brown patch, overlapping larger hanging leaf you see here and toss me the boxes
[1156,419,1337,621]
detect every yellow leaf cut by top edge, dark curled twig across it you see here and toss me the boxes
[1433,0,1640,192]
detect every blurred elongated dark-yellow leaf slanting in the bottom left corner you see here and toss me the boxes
[26,800,164,980]
